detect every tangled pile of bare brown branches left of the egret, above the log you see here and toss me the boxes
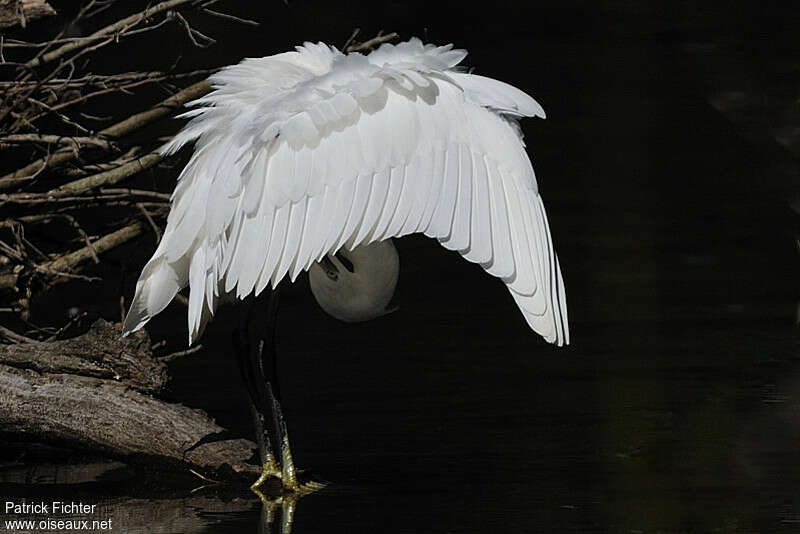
[0,0,256,341]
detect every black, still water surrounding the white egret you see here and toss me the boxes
[0,2,800,533]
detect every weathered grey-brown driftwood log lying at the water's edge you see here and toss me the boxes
[0,320,259,479]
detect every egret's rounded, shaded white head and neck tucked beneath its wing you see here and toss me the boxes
[308,239,400,323]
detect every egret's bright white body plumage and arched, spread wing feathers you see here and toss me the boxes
[125,39,569,345]
